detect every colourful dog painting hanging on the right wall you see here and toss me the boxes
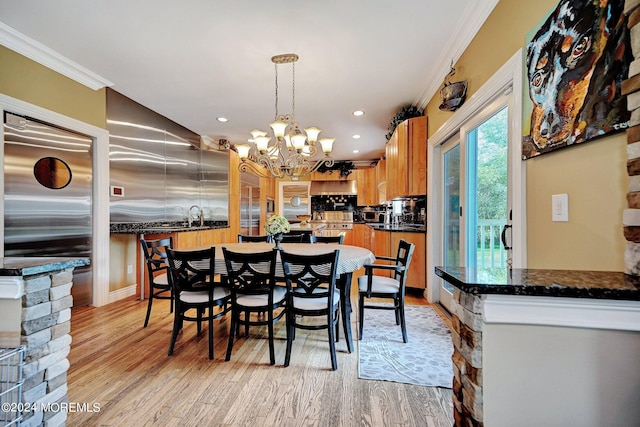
[522,0,632,159]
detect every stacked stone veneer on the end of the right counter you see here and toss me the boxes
[451,288,484,427]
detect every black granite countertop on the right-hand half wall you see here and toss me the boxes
[435,267,640,301]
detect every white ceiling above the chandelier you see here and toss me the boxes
[0,0,497,161]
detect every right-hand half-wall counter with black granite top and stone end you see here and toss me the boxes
[435,267,640,427]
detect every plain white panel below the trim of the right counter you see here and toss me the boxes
[482,324,640,427]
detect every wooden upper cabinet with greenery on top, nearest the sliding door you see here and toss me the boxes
[386,116,427,200]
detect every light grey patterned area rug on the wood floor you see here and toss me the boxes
[358,306,453,388]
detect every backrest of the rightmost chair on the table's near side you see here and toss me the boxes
[280,250,340,307]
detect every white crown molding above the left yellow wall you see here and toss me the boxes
[0,21,113,90]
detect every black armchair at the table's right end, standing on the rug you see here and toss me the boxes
[358,240,415,343]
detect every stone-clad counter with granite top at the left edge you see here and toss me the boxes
[0,257,90,426]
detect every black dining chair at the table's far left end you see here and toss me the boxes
[140,237,174,328]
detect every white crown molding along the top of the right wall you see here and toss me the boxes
[413,0,499,109]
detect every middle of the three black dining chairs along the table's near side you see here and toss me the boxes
[222,247,287,365]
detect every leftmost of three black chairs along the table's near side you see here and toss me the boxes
[167,247,231,360]
